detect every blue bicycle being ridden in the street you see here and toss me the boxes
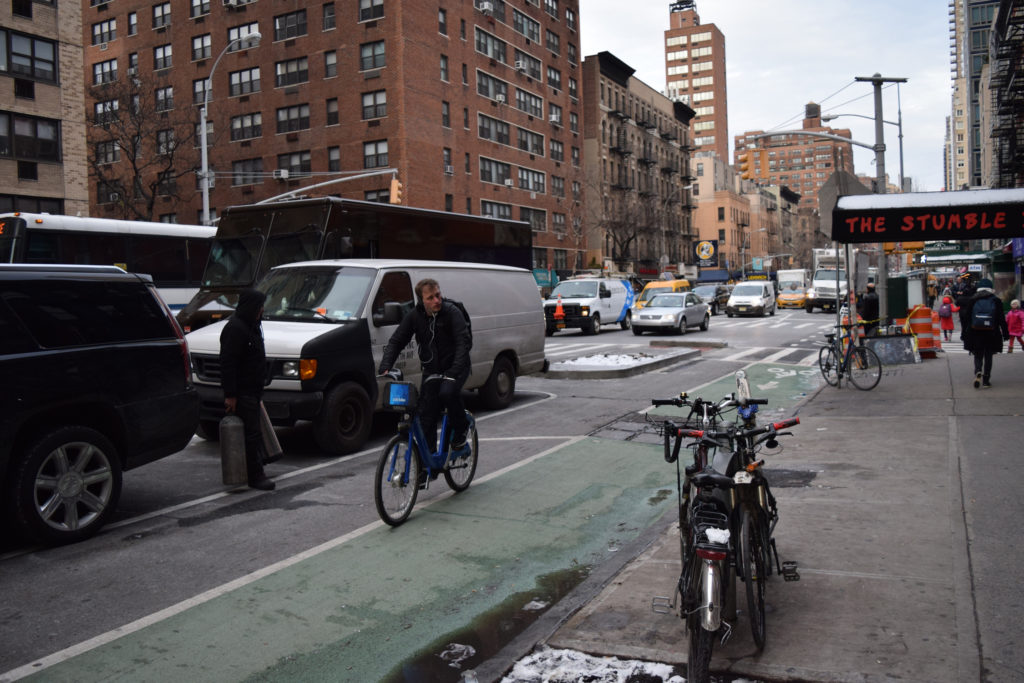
[374,370,479,526]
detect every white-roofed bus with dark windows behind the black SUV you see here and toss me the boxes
[0,212,217,310]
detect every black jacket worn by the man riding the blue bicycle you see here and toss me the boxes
[378,300,470,378]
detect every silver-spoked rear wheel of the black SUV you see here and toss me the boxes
[10,425,121,545]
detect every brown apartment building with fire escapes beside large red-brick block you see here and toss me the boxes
[583,52,696,278]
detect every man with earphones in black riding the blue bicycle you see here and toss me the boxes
[378,279,471,451]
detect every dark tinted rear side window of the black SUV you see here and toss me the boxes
[0,280,175,348]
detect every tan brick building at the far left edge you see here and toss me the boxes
[0,0,89,214]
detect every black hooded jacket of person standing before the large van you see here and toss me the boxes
[220,290,266,398]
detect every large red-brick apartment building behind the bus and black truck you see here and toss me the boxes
[82,0,584,267]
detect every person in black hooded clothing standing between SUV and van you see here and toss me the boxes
[220,289,274,490]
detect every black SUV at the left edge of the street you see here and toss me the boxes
[0,264,199,544]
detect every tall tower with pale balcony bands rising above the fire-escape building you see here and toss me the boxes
[665,0,729,160]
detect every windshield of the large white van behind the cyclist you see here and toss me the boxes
[259,266,376,323]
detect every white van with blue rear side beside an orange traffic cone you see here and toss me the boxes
[544,278,634,337]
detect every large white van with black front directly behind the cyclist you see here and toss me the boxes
[187,259,547,454]
